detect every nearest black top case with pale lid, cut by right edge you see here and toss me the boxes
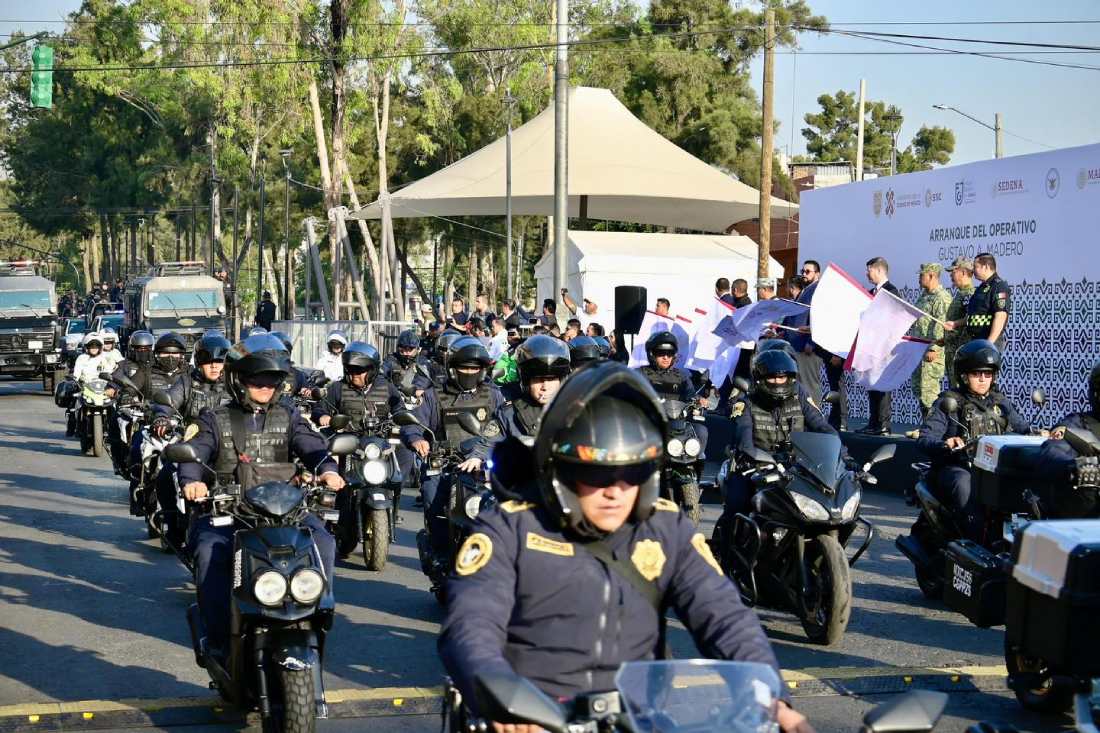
[1005,519,1100,677]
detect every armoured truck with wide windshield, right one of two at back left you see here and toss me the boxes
[122,261,226,348]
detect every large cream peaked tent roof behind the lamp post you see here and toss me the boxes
[351,87,798,232]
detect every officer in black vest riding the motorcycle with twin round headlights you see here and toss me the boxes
[177,333,344,655]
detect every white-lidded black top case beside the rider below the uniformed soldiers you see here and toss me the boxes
[971,435,1047,512]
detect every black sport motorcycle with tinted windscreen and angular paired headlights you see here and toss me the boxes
[718,433,895,645]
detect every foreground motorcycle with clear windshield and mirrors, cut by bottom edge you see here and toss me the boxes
[455,659,947,733]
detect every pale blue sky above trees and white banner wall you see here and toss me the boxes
[0,0,1100,163]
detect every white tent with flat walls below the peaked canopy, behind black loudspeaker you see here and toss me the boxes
[535,231,783,330]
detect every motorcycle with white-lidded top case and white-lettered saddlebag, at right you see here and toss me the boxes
[894,390,1048,603]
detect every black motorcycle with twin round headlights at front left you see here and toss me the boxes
[164,435,359,732]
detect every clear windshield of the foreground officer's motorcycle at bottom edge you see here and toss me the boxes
[615,659,780,733]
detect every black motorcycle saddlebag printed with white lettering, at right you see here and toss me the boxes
[944,539,1007,628]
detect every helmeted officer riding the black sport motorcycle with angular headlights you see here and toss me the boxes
[714,348,837,537]
